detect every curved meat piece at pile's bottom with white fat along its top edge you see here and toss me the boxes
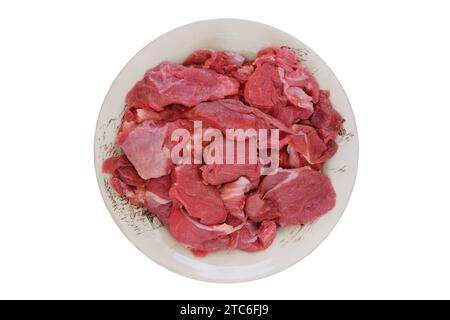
[168,203,242,252]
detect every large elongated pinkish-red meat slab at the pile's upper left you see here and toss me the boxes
[126,62,239,111]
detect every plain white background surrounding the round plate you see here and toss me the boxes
[0,0,450,299]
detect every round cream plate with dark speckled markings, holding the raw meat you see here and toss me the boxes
[95,19,358,282]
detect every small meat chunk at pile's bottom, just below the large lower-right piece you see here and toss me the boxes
[237,221,277,252]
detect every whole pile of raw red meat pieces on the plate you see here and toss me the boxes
[103,48,343,256]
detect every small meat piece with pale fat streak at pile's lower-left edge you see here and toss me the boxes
[145,175,172,225]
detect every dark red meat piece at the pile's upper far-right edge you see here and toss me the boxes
[309,91,344,143]
